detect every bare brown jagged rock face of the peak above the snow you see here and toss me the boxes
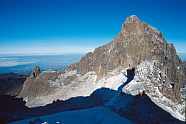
[69,16,184,99]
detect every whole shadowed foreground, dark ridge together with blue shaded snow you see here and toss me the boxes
[7,88,184,124]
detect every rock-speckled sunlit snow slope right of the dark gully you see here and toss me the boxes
[129,61,185,121]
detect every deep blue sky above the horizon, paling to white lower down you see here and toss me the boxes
[0,0,186,54]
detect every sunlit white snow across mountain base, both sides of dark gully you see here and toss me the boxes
[26,61,185,121]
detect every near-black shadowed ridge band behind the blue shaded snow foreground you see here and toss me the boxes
[4,88,184,124]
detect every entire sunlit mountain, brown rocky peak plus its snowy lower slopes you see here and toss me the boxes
[19,16,186,121]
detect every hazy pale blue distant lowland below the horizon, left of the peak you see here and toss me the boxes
[0,54,82,74]
